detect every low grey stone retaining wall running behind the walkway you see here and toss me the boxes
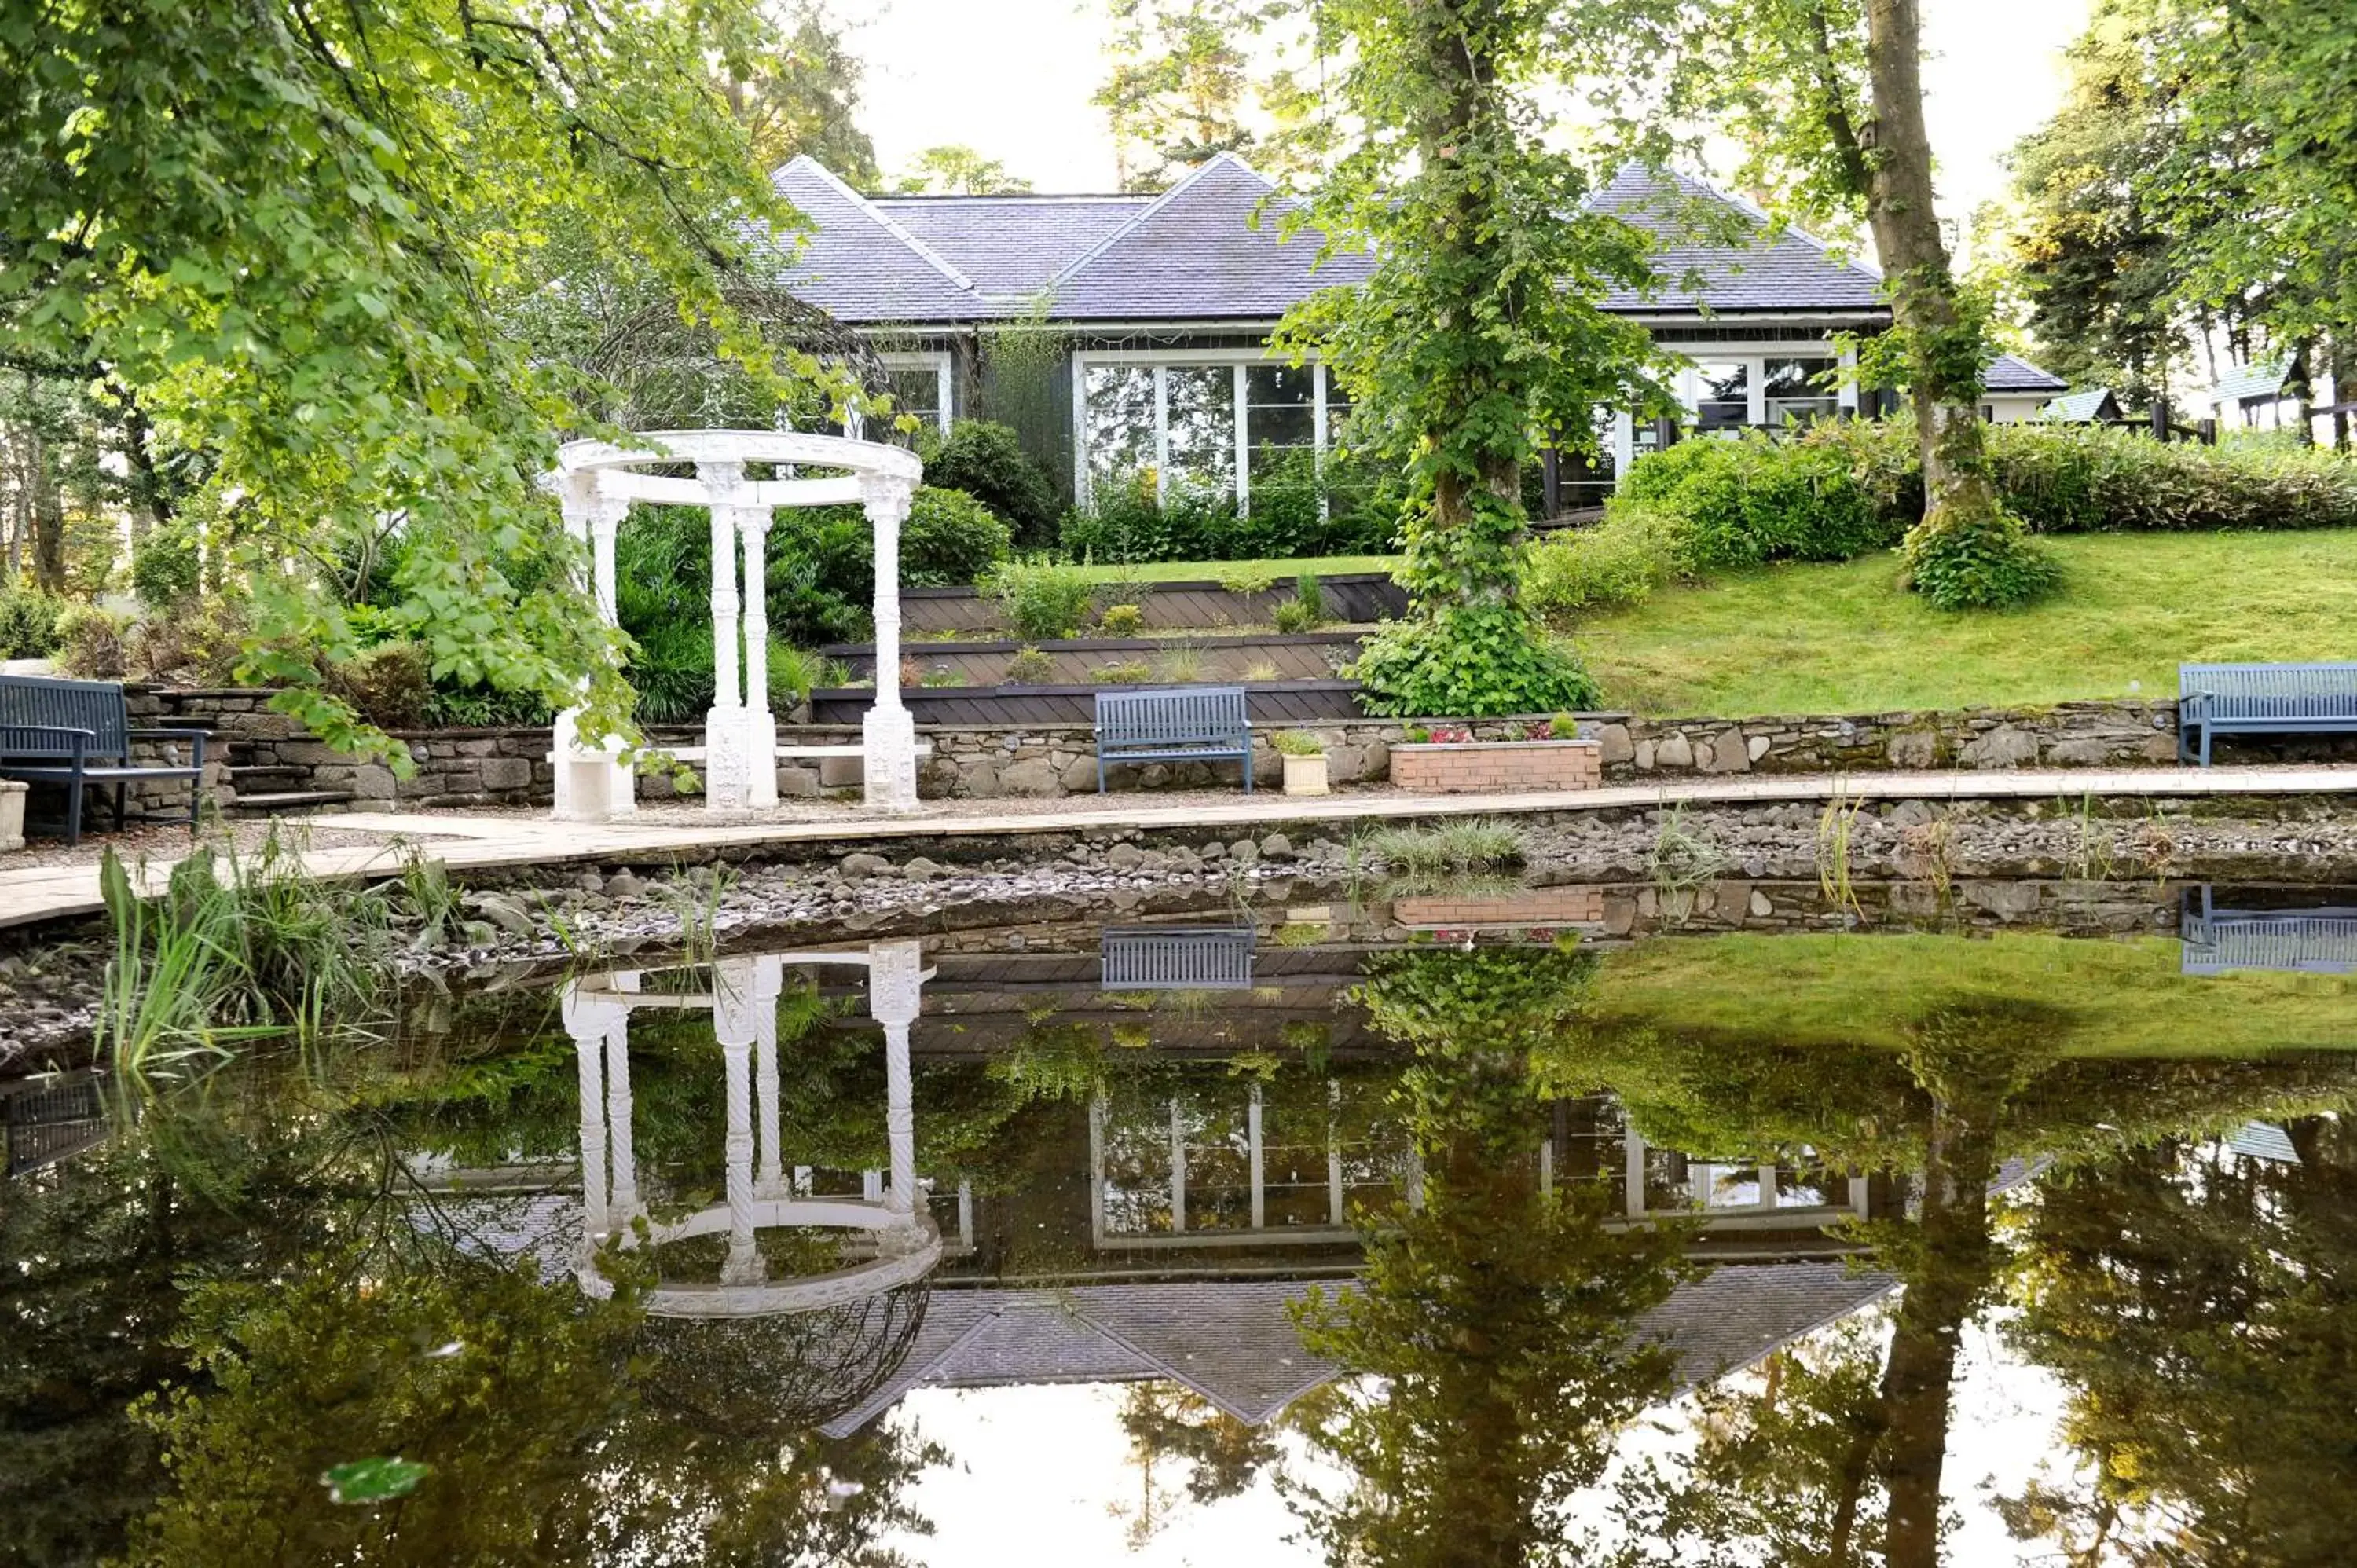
[132,691,2357,811]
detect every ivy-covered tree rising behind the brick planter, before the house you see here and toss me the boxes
[1280,0,1664,714]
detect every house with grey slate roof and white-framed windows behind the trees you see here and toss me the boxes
[773,153,2065,502]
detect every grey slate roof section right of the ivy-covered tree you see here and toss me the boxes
[1589,163,1888,316]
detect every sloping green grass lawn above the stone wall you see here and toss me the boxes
[1577,530,2357,716]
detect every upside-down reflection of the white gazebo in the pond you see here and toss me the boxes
[563,941,943,1318]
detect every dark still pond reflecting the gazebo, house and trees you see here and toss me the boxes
[0,885,2357,1568]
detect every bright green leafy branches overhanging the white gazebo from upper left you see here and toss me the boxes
[0,0,867,745]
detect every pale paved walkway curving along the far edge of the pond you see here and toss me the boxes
[0,766,2357,927]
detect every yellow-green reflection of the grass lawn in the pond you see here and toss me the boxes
[1596,932,2357,1057]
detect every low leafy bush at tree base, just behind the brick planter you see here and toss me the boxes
[1351,601,1598,719]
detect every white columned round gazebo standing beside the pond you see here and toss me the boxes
[547,429,924,823]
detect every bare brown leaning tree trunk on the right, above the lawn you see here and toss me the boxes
[1860,0,1996,523]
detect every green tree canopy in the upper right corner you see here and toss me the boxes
[2013,0,2357,441]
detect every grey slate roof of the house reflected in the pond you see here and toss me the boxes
[823,1262,1895,1438]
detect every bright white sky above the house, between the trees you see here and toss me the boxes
[837,0,2086,231]
